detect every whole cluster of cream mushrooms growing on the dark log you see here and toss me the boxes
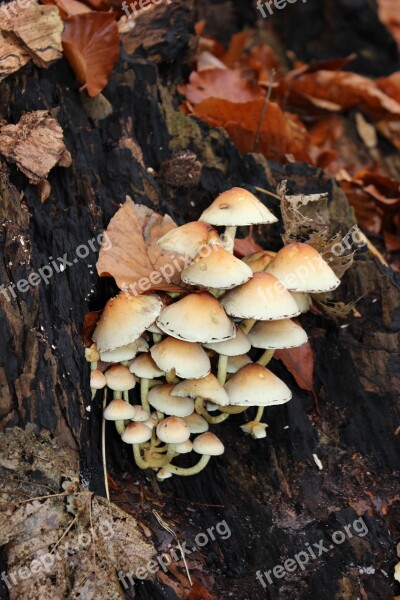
[87,188,340,480]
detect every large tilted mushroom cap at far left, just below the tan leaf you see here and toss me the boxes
[93,292,163,352]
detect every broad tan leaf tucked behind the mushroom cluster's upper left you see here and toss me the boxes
[97,197,189,294]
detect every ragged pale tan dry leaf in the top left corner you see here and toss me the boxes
[0,2,64,68]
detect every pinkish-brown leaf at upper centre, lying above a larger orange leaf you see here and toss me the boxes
[181,69,265,104]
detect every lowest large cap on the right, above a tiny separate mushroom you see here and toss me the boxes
[225,363,292,406]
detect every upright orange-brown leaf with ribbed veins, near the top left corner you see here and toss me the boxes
[62,12,119,96]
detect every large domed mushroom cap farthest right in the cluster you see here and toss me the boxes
[267,242,340,294]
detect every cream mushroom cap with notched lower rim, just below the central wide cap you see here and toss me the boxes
[150,337,211,379]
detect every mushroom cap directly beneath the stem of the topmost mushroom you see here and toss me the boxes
[181,245,253,290]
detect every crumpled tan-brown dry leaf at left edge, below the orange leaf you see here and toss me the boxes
[0,110,71,183]
